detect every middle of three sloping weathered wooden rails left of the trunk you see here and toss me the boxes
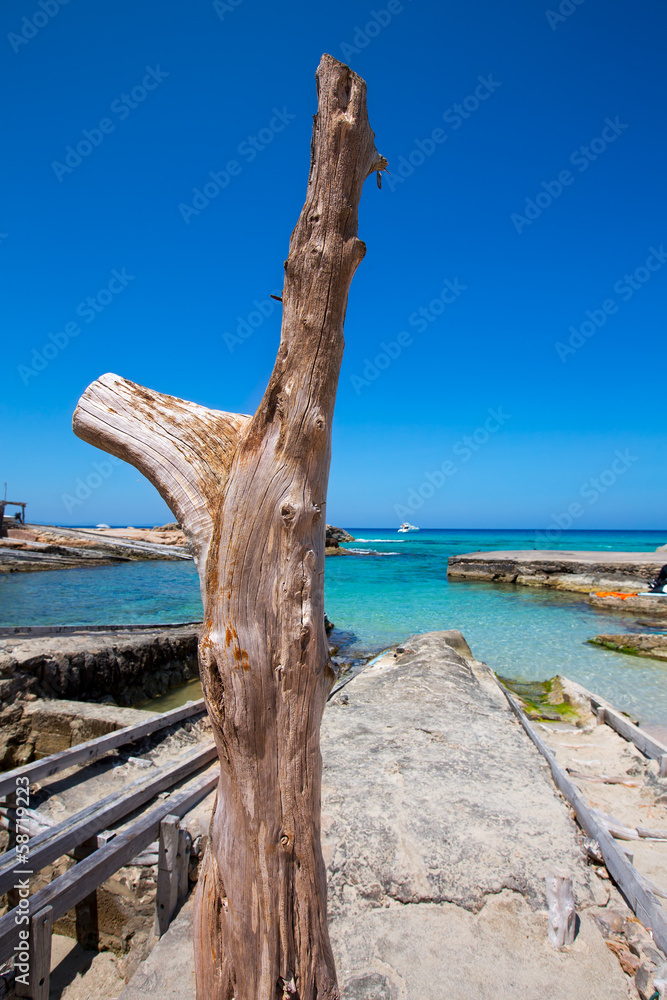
[0,745,216,895]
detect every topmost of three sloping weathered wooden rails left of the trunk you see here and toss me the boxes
[0,698,206,796]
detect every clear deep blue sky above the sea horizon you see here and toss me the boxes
[0,0,667,529]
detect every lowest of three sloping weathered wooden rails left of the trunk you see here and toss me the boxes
[0,767,219,962]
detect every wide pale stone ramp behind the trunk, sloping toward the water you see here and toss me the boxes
[121,632,633,1000]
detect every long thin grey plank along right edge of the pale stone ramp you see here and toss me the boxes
[498,671,667,953]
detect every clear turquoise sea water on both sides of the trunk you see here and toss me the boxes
[0,528,667,725]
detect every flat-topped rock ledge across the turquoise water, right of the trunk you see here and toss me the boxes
[447,549,665,593]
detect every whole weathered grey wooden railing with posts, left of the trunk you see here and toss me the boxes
[0,700,214,1000]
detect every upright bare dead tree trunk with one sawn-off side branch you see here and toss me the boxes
[74,55,386,1000]
